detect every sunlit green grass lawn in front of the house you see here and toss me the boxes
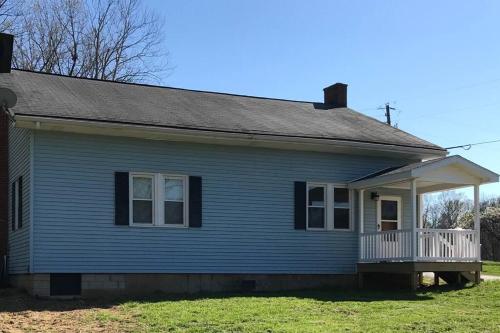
[91,282,500,332]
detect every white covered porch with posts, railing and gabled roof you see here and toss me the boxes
[349,156,498,263]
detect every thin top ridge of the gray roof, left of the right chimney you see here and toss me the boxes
[12,68,316,104]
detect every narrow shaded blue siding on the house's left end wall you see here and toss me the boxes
[9,126,31,274]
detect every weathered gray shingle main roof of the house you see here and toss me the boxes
[0,70,443,150]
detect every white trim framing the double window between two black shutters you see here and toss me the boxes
[129,172,189,229]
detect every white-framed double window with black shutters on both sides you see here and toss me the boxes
[129,173,188,227]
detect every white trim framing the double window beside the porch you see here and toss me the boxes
[306,182,354,232]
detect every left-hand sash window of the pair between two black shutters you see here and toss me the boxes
[131,175,154,224]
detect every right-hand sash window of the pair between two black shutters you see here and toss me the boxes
[163,176,186,226]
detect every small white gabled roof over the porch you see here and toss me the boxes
[349,155,499,193]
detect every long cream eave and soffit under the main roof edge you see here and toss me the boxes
[15,114,447,160]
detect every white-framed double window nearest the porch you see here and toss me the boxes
[307,183,352,230]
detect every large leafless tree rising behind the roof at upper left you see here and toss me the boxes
[9,0,169,82]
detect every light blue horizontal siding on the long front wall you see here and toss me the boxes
[34,132,412,273]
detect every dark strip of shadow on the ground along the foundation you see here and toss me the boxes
[0,285,471,313]
